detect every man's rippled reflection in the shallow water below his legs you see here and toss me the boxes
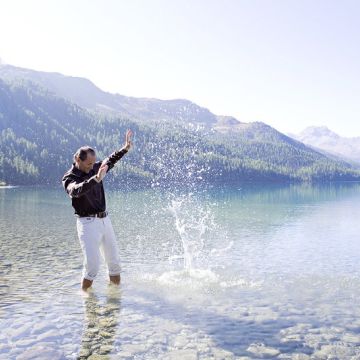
[78,285,121,359]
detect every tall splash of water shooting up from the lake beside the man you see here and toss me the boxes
[141,126,239,286]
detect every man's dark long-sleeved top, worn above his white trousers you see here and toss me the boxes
[62,149,127,216]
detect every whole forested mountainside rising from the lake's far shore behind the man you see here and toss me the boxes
[0,66,360,186]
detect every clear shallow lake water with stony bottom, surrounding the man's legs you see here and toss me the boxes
[0,184,360,360]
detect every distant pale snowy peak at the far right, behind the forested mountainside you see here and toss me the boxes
[291,126,360,164]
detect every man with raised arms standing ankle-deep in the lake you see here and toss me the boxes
[62,130,132,291]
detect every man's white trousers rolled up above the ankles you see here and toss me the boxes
[76,216,121,280]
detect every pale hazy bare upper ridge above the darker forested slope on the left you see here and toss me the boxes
[0,65,231,127]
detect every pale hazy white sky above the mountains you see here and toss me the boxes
[0,0,360,136]
